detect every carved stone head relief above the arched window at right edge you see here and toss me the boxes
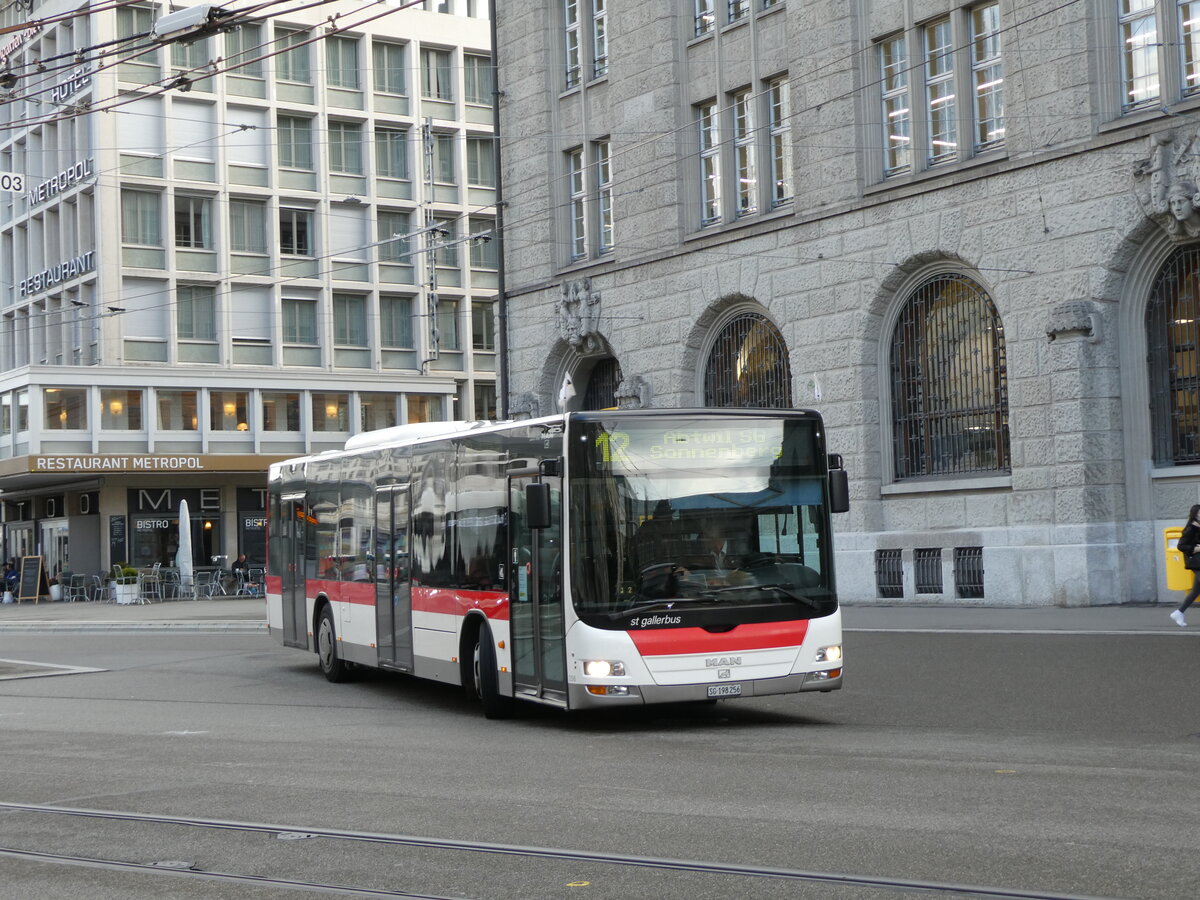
[1133,132,1200,240]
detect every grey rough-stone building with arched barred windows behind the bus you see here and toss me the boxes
[497,0,1200,606]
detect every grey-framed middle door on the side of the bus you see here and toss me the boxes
[374,485,413,672]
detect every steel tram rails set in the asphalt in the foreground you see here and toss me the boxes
[0,802,1114,900]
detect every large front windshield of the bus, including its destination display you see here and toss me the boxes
[569,416,838,628]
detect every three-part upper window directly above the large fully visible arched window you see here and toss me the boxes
[877,0,1004,178]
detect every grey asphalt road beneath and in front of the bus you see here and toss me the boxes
[0,631,1200,900]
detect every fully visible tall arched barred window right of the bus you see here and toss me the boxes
[890,275,1010,480]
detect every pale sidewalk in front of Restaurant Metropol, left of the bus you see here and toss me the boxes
[0,596,266,635]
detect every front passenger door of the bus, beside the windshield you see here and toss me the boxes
[509,476,566,702]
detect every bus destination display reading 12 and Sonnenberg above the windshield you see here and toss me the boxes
[594,427,784,466]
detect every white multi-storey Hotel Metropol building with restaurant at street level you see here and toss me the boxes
[0,0,498,572]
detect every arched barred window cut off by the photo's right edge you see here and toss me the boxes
[1146,247,1200,466]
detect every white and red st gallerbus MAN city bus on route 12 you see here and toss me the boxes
[266,409,850,719]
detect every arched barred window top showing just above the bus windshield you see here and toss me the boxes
[704,312,792,409]
